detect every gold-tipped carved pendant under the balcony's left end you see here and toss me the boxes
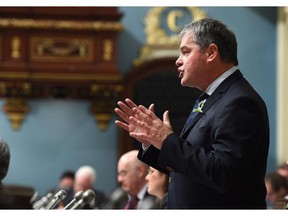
[3,97,29,130]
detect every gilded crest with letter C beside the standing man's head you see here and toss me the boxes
[133,7,206,66]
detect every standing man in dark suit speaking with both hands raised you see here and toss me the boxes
[115,18,269,209]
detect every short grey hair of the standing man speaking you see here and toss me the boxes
[179,18,238,65]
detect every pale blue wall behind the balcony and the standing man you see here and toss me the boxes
[0,7,277,195]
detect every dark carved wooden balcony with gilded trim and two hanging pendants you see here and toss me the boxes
[0,7,123,130]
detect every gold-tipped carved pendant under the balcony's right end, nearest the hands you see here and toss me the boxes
[91,84,123,131]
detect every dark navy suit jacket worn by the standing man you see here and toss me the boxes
[138,70,269,209]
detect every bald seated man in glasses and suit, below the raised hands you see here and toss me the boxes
[118,150,156,209]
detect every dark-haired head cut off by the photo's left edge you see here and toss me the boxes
[0,138,10,182]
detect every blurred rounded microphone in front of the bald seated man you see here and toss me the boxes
[104,188,128,209]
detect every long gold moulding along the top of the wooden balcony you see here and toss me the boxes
[0,18,123,31]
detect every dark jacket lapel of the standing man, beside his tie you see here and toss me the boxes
[180,70,243,137]
